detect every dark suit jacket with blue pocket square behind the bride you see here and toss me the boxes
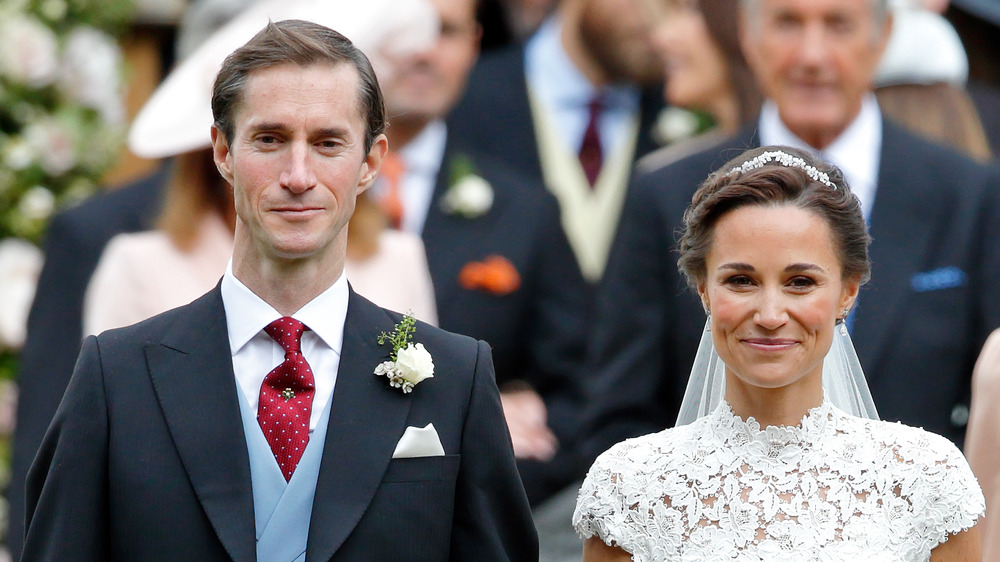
[587,122,1000,455]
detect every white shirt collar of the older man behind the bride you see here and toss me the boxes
[760,93,882,221]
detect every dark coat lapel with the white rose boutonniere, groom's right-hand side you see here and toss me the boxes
[306,290,412,560]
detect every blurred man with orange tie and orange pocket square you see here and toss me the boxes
[373,0,587,505]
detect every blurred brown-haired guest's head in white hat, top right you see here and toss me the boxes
[875,5,993,161]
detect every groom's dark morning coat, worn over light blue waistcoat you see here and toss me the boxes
[24,288,538,562]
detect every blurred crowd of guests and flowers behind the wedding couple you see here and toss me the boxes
[0,0,1000,560]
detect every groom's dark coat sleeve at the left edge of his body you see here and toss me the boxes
[21,337,109,562]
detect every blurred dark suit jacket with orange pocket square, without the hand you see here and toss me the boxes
[422,142,588,503]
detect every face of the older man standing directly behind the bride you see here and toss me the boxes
[740,0,891,148]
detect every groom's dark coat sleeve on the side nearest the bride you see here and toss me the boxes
[451,341,538,561]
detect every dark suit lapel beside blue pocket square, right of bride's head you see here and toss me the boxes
[853,120,941,373]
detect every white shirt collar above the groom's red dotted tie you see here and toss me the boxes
[221,259,349,355]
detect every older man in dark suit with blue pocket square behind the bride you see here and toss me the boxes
[588,0,1000,455]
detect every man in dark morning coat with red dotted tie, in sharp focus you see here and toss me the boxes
[23,20,537,561]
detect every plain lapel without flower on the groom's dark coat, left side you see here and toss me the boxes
[146,287,256,560]
